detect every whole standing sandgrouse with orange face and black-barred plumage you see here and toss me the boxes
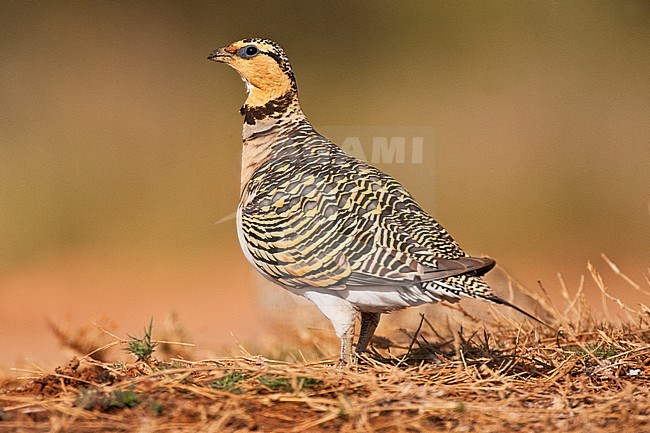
[208,38,548,365]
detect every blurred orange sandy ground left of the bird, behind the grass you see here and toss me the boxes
[0,251,260,370]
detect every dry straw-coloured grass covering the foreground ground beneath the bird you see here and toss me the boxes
[0,259,650,433]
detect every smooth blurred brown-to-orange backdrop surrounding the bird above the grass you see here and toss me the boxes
[0,0,650,368]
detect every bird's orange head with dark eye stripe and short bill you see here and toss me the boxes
[208,38,296,107]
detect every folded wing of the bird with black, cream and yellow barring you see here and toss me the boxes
[235,140,494,288]
